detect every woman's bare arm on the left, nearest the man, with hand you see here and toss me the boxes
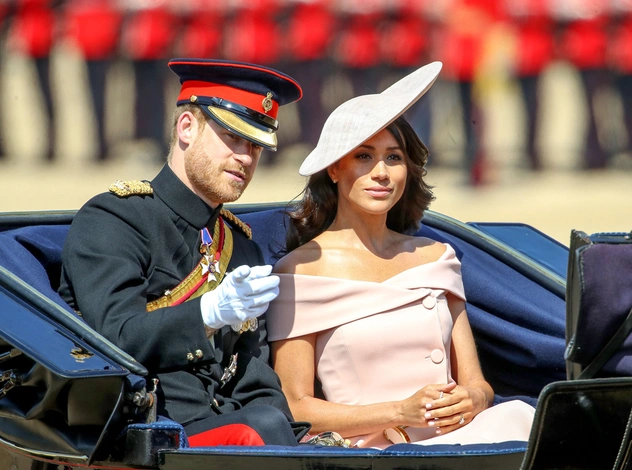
[271,334,440,438]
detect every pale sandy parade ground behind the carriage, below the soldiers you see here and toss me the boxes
[0,156,632,244]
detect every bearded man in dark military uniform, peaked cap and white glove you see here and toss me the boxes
[60,59,306,445]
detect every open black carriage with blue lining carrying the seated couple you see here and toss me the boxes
[0,204,632,470]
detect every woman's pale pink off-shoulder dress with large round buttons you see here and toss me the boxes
[266,244,535,448]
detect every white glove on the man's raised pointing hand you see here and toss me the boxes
[200,265,279,330]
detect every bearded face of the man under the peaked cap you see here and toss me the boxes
[184,119,262,206]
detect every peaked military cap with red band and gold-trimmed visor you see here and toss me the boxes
[169,59,303,150]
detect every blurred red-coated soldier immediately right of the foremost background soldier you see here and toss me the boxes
[505,0,555,170]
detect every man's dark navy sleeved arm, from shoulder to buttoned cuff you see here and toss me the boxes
[60,195,213,370]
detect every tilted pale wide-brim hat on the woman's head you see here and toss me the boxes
[298,62,443,176]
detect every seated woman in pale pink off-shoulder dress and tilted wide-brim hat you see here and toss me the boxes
[267,62,534,448]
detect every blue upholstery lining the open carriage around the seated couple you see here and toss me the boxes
[0,209,565,464]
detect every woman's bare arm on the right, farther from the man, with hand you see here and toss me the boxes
[428,293,494,434]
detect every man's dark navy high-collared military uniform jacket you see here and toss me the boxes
[59,166,291,425]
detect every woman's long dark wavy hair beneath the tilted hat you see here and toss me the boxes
[285,116,434,253]
